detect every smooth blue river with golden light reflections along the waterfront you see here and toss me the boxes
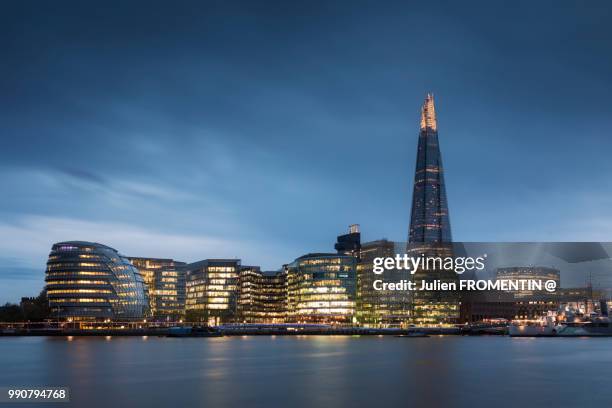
[0,336,612,408]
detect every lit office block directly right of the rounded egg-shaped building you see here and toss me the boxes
[128,257,185,320]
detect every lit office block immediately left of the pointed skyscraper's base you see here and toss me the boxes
[356,239,411,327]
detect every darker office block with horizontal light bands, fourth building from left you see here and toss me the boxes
[237,266,287,323]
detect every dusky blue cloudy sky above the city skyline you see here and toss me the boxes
[0,0,612,303]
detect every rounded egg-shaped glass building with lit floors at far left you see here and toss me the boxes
[45,241,149,321]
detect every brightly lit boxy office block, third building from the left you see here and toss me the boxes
[181,259,240,325]
